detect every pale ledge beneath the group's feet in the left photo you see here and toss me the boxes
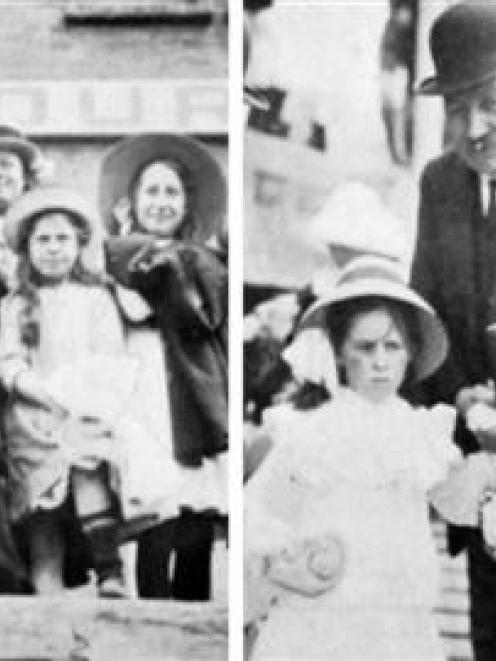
[0,595,228,661]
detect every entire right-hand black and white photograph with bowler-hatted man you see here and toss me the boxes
[243,0,496,661]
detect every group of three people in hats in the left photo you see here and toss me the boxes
[0,125,228,601]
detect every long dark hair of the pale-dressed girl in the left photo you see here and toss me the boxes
[14,209,106,348]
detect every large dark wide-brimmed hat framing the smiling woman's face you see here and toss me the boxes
[99,133,226,242]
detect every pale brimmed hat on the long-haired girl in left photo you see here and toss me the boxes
[3,186,100,252]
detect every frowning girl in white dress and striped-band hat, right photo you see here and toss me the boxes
[245,258,461,661]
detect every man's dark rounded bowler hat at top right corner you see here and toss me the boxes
[417,0,496,95]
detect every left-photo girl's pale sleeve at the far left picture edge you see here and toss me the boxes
[0,295,31,392]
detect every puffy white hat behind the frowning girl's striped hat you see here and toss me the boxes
[310,181,409,261]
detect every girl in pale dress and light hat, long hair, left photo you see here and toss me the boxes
[0,187,138,597]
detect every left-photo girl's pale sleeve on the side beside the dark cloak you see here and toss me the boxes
[90,287,124,354]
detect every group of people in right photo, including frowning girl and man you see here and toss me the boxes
[245,1,496,661]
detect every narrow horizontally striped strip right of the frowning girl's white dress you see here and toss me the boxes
[432,520,473,661]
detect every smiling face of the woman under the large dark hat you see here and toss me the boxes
[134,162,186,238]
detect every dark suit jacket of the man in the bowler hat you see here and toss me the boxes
[411,148,496,553]
